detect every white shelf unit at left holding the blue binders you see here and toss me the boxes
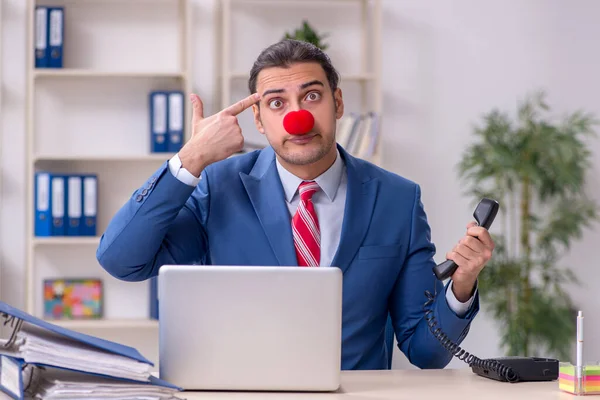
[25,0,192,362]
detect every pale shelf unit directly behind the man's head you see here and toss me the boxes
[217,0,383,165]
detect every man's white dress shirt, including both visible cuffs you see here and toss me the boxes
[169,151,475,316]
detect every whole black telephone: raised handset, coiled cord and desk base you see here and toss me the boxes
[424,198,559,383]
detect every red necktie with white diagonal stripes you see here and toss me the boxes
[292,181,321,267]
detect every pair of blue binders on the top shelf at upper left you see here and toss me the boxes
[35,6,65,68]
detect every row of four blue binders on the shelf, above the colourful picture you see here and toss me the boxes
[34,172,98,237]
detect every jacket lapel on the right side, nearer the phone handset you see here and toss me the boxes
[331,146,378,272]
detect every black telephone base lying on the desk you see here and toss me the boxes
[471,356,559,382]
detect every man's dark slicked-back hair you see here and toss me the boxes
[248,39,340,93]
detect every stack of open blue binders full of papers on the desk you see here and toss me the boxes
[0,302,182,399]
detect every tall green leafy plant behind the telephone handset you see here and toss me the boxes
[458,92,598,360]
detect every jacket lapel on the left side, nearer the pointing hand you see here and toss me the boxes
[240,147,298,266]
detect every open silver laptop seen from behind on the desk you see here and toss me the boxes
[158,265,342,391]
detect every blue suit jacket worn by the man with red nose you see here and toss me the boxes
[97,146,479,369]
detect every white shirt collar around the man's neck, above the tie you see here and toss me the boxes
[275,150,344,203]
